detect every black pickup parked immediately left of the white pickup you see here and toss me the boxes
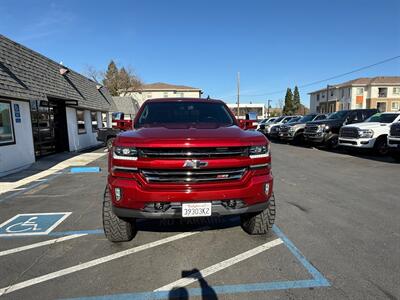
[304,109,378,148]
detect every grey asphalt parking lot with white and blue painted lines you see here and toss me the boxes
[0,144,400,299]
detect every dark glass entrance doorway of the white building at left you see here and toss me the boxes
[31,100,68,157]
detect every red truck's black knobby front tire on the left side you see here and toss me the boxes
[103,187,136,243]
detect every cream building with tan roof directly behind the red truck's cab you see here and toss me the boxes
[120,82,203,106]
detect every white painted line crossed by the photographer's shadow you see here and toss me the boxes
[154,239,283,292]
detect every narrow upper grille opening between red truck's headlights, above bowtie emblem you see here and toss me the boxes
[138,147,248,158]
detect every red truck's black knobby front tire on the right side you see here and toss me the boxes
[240,194,276,235]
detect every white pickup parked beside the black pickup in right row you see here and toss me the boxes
[339,112,400,155]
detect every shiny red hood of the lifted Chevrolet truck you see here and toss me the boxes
[115,126,267,148]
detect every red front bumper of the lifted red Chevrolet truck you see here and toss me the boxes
[108,170,273,218]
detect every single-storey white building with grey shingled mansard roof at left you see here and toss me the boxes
[0,35,116,176]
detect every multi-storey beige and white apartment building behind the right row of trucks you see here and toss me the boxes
[309,76,400,113]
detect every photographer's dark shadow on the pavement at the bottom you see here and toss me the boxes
[168,269,218,300]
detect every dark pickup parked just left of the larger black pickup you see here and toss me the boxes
[279,114,326,144]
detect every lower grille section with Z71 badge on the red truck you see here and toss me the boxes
[140,168,246,183]
